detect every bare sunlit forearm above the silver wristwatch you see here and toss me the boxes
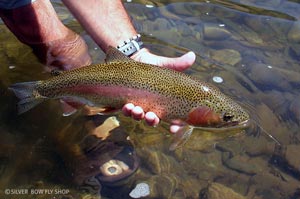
[63,0,137,51]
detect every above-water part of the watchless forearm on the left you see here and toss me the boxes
[0,0,68,44]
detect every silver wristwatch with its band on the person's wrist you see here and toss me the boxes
[117,34,143,57]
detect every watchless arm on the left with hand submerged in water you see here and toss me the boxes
[0,0,91,70]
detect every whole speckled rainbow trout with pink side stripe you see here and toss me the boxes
[9,47,250,150]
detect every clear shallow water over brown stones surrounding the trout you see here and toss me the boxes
[0,0,300,198]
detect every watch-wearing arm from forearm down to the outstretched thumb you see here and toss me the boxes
[63,0,196,71]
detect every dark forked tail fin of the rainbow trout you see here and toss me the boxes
[9,81,44,114]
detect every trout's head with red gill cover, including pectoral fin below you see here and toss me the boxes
[170,94,250,150]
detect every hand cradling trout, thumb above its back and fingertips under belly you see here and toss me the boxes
[122,48,196,133]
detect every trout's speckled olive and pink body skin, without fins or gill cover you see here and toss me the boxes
[12,47,249,126]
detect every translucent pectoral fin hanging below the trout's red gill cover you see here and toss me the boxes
[169,125,194,151]
